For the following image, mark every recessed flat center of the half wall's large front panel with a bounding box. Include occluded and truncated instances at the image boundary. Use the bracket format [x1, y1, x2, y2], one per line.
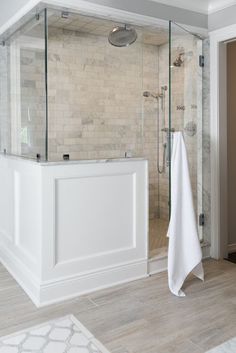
[55, 174, 136, 264]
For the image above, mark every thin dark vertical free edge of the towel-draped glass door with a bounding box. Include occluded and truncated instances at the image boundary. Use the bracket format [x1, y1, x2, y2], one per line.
[168, 21, 172, 218]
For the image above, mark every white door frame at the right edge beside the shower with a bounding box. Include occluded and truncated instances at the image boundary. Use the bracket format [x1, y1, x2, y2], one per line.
[209, 25, 236, 259]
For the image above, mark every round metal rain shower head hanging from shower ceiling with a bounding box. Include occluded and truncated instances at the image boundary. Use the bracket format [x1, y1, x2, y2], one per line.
[108, 25, 138, 47]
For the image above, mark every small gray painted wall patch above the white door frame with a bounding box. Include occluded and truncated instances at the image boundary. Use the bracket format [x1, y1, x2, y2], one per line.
[208, 5, 236, 31]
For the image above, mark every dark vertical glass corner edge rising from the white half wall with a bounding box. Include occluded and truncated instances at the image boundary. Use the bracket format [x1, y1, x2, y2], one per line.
[44, 8, 48, 161]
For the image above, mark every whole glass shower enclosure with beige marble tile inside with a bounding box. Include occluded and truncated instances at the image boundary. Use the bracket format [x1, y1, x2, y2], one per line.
[0, 9, 204, 257]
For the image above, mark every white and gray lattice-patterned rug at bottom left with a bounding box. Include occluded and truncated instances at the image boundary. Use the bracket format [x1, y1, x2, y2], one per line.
[0, 315, 109, 353]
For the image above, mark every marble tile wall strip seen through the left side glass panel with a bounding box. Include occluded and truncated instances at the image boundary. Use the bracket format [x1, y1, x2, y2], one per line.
[20, 48, 46, 159]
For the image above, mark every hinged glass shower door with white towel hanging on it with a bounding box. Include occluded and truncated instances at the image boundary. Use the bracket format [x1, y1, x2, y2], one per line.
[169, 23, 202, 240]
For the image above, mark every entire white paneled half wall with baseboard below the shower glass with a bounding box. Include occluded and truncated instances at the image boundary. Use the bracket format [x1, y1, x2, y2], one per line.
[0, 156, 148, 306]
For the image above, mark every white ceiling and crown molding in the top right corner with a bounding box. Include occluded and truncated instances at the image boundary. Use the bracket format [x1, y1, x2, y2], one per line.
[151, 0, 236, 14]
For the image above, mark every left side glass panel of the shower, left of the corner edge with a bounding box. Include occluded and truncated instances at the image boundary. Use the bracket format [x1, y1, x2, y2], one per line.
[0, 12, 46, 160]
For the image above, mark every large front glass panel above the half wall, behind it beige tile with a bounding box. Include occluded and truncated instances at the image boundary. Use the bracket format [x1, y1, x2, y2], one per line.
[45, 11, 143, 161]
